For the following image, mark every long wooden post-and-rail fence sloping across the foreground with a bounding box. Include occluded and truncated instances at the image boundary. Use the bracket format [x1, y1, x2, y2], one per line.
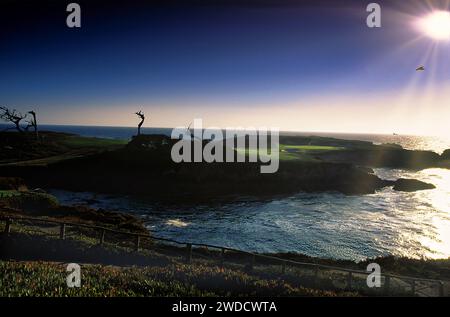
[0, 216, 450, 296]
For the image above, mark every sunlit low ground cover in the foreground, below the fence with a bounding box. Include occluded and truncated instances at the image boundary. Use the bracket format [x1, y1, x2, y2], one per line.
[0, 262, 355, 297]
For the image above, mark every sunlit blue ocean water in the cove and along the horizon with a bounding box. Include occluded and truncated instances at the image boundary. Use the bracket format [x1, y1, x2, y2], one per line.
[2, 126, 450, 261]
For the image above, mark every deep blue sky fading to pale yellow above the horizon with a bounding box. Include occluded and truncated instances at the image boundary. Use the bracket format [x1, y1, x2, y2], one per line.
[0, 0, 450, 135]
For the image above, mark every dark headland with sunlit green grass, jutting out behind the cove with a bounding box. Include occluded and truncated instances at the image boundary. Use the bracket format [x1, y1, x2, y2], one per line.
[0, 133, 446, 199]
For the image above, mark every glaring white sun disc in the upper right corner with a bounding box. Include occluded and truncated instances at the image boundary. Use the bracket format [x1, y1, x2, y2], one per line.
[418, 11, 450, 40]
